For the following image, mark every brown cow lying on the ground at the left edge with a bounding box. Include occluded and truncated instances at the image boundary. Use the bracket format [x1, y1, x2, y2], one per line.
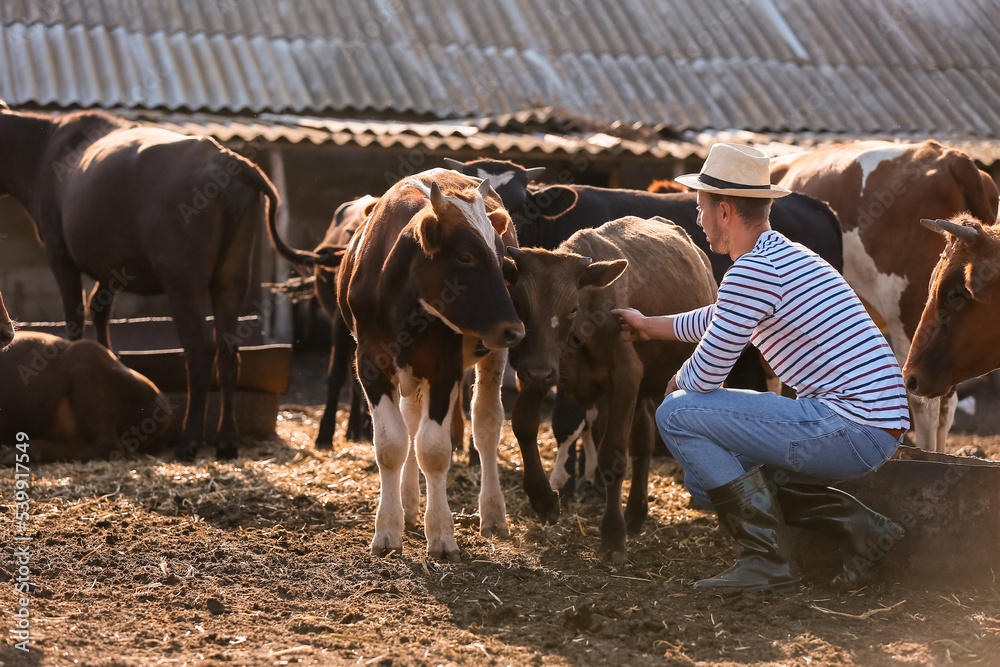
[0, 331, 176, 465]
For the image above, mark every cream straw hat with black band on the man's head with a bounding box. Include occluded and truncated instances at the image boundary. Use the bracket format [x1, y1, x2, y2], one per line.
[675, 144, 791, 198]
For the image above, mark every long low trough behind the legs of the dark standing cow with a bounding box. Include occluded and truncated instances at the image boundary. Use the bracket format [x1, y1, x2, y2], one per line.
[18, 316, 292, 438]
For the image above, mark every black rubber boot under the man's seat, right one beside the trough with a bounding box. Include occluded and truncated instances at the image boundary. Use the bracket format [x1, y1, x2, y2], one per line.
[777, 484, 903, 589]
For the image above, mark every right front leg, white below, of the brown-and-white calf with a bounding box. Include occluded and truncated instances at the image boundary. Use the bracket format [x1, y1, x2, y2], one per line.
[414, 374, 462, 561]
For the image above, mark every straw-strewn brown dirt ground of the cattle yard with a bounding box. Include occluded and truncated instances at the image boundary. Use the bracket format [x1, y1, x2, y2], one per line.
[0, 358, 1000, 667]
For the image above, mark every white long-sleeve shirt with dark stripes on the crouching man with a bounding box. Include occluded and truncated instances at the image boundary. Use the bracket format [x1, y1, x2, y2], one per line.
[674, 231, 909, 429]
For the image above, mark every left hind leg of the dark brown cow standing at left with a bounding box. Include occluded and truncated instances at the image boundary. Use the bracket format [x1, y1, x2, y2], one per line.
[168, 292, 212, 461]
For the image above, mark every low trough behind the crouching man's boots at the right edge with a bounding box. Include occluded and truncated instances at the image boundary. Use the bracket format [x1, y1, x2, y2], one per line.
[793, 446, 1000, 586]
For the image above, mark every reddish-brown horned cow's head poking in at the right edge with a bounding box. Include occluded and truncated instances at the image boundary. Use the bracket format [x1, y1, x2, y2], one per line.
[903, 213, 1000, 398]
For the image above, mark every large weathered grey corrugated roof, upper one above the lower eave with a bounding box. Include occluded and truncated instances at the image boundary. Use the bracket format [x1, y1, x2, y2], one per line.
[0, 0, 1000, 137]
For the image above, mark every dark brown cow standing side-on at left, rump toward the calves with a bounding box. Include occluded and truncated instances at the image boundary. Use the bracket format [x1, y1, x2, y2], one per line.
[0, 110, 321, 460]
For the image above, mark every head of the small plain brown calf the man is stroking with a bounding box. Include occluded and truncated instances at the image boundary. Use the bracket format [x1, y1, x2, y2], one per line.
[507, 248, 628, 386]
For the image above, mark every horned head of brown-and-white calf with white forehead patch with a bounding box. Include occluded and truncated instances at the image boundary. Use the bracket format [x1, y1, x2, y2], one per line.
[409, 181, 524, 349]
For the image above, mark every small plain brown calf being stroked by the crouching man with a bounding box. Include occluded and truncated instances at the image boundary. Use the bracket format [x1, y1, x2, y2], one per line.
[508, 217, 716, 563]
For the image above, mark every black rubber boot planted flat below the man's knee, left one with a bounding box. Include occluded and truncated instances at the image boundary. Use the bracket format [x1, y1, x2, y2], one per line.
[695, 466, 799, 592]
